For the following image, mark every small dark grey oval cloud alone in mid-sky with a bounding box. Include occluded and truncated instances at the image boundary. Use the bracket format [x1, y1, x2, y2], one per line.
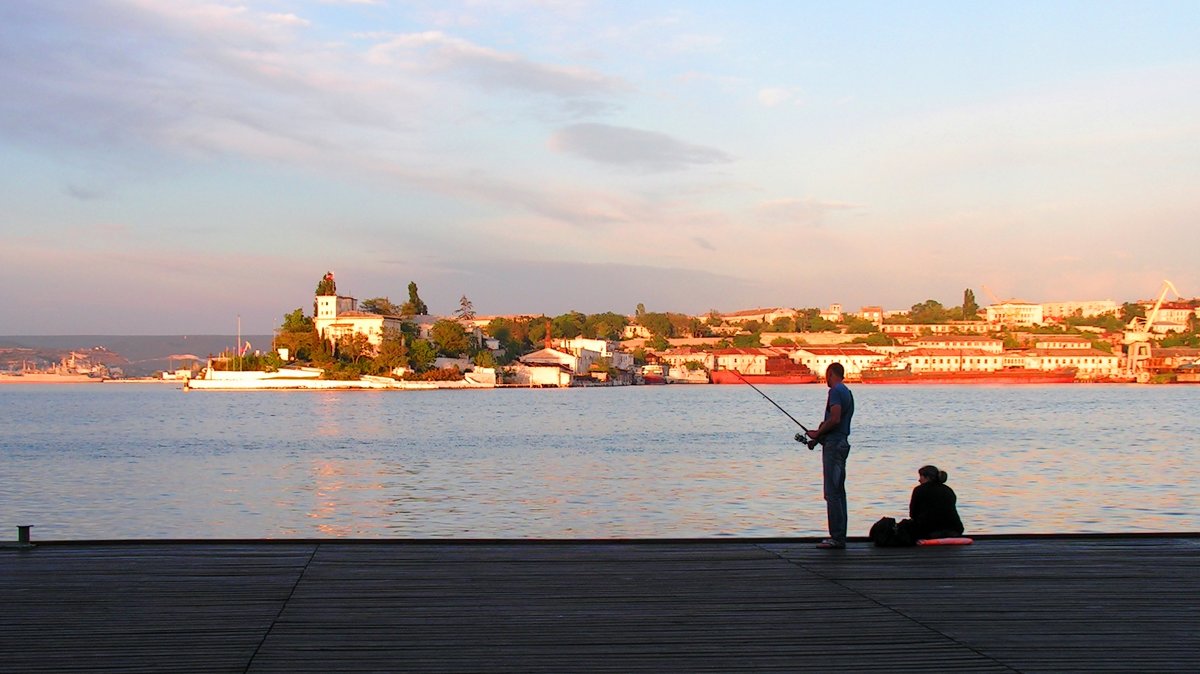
[550, 124, 733, 171]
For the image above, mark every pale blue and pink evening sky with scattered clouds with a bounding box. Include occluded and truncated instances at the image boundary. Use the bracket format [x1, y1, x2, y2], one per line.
[0, 0, 1200, 335]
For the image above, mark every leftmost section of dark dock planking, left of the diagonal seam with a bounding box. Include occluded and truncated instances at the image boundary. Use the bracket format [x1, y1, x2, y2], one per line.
[0, 544, 314, 672]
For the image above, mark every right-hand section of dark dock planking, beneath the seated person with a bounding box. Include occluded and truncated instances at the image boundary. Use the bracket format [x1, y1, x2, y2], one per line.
[774, 537, 1200, 672]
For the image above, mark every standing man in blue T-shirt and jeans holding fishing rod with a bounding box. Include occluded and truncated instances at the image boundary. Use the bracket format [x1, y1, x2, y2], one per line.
[809, 362, 854, 549]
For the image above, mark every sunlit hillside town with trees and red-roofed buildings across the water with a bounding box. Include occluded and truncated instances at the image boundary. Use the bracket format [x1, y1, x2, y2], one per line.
[179, 272, 1200, 387]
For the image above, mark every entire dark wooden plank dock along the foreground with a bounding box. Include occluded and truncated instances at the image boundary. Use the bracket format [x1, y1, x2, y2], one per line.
[0, 535, 1200, 673]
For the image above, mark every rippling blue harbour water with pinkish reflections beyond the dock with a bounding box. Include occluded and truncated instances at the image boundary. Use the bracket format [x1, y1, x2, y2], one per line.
[0, 384, 1200, 540]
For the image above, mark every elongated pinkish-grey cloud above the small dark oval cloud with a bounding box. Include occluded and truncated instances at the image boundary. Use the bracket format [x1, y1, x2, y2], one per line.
[366, 31, 629, 98]
